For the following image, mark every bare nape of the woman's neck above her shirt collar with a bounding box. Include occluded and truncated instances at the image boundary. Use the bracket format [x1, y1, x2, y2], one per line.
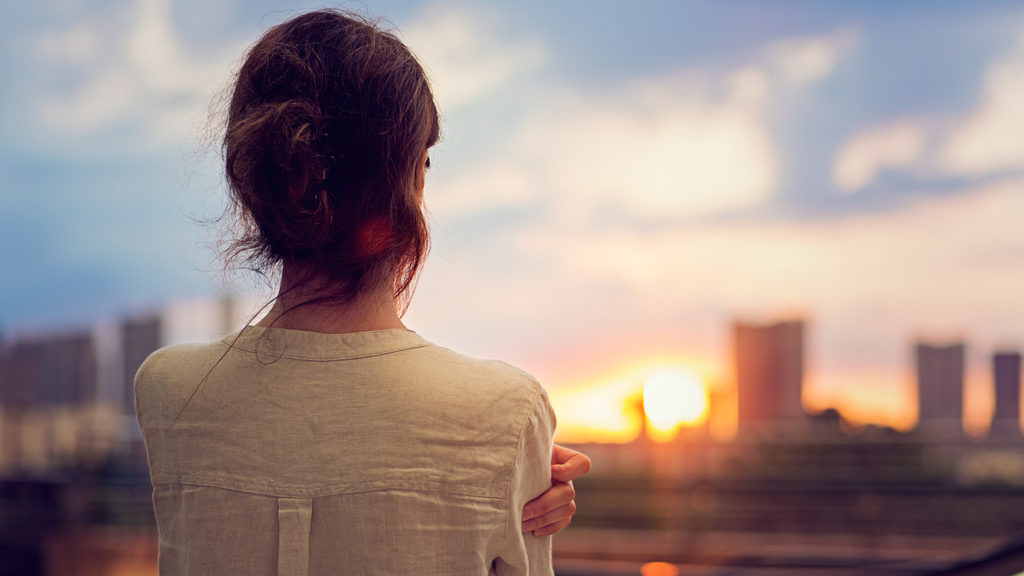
[256, 263, 406, 334]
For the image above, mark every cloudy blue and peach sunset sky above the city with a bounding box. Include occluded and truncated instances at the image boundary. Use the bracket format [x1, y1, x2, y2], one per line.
[0, 0, 1024, 440]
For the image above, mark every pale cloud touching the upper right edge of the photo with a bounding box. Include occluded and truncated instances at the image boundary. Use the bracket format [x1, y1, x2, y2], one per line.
[940, 28, 1024, 176]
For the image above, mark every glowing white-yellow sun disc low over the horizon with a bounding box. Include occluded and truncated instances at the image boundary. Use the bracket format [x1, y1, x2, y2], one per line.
[643, 370, 708, 433]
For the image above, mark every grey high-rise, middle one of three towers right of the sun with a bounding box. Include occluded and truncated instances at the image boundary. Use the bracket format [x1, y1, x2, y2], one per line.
[914, 342, 965, 436]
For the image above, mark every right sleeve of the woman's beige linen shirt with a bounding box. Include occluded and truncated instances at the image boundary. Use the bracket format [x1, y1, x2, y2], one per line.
[495, 381, 555, 576]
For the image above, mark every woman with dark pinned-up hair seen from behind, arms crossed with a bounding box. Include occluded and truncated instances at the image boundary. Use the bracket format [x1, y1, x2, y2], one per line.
[135, 10, 589, 576]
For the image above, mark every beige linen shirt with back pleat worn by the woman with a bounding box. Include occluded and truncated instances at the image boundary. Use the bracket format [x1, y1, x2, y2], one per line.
[135, 327, 554, 576]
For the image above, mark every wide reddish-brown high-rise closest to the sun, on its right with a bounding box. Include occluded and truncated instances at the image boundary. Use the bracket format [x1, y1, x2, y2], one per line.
[733, 321, 804, 435]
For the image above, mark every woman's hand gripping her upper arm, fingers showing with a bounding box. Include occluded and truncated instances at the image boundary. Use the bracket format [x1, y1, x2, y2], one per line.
[522, 444, 590, 536]
